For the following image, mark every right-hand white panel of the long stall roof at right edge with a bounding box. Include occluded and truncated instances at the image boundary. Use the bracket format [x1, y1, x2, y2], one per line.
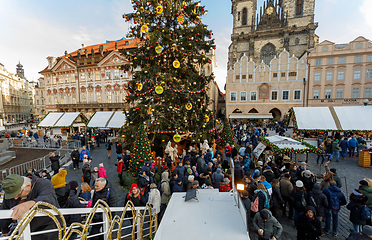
[334, 106, 372, 131]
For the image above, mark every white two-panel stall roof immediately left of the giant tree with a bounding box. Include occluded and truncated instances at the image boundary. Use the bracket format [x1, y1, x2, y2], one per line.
[87, 111, 126, 128]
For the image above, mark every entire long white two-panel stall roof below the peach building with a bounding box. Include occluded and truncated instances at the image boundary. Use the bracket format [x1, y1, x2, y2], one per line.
[292, 106, 372, 131]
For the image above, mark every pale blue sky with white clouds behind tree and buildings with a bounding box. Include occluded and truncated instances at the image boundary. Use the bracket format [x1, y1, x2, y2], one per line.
[0, 0, 372, 92]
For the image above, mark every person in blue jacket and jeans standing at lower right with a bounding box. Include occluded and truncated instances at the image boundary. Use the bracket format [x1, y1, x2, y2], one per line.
[323, 180, 346, 236]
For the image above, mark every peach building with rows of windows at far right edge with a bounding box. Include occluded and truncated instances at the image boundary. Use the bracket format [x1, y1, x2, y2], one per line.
[307, 37, 372, 107]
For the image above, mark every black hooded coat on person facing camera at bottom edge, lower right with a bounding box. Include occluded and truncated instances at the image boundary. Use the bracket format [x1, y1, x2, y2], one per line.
[295, 206, 322, 240]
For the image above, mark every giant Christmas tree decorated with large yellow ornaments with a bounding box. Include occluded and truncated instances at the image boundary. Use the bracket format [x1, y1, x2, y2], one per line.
[121, 0, 215, 148]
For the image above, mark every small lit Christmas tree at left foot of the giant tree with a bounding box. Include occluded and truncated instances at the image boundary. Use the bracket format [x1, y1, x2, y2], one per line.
[129, 125, 151, 177]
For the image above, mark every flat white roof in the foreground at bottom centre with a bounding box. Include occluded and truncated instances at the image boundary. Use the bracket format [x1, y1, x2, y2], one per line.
[155, 189, 249, 240]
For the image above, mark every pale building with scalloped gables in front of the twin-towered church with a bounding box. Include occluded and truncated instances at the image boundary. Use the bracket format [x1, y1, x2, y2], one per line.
[226, 51, 308, 119]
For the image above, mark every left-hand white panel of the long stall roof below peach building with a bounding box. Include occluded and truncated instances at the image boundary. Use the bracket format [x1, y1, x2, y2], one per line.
[293, 107, 337, 130]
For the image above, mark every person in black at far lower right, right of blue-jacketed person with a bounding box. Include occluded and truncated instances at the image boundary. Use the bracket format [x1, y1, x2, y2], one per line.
[346, 189, 368, 232]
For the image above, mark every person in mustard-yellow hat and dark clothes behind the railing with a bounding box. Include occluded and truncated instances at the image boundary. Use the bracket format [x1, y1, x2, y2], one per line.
[51, 170, 70, 208]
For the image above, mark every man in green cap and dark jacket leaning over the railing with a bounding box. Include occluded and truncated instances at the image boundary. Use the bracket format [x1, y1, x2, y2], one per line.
[0, 174, 59, 240]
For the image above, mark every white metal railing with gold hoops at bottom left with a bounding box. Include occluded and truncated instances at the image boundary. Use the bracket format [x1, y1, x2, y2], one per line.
[0, 200, 158, 240]
